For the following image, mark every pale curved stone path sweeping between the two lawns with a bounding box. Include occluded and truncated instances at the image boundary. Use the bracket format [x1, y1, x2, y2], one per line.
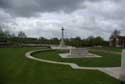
[25, 49, 121, 79]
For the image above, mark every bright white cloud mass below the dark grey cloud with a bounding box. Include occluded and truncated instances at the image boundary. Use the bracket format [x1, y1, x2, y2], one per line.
[0, 0, 125, 39]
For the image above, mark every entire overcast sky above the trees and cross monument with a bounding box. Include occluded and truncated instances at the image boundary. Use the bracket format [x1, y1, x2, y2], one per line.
[0, 0, 125, 39]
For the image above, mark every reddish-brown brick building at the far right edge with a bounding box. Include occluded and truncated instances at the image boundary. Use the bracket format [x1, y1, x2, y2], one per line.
[109, 36, 125, 48]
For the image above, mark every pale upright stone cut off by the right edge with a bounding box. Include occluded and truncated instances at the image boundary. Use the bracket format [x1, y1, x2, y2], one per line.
[120, 50, 125, 81]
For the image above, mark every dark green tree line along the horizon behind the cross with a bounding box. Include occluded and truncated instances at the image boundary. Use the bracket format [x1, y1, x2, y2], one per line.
[0, 28, 108, 47]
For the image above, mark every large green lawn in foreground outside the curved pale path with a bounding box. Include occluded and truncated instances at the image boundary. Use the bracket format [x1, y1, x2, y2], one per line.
[0, 48, 119, 84]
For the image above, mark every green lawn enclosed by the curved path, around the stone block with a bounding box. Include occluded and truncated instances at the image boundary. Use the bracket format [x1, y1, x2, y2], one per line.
[35, 48, 121, 67]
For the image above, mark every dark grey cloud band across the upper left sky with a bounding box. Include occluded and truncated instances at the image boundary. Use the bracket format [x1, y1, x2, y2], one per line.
[0, 0, 83, 16]
